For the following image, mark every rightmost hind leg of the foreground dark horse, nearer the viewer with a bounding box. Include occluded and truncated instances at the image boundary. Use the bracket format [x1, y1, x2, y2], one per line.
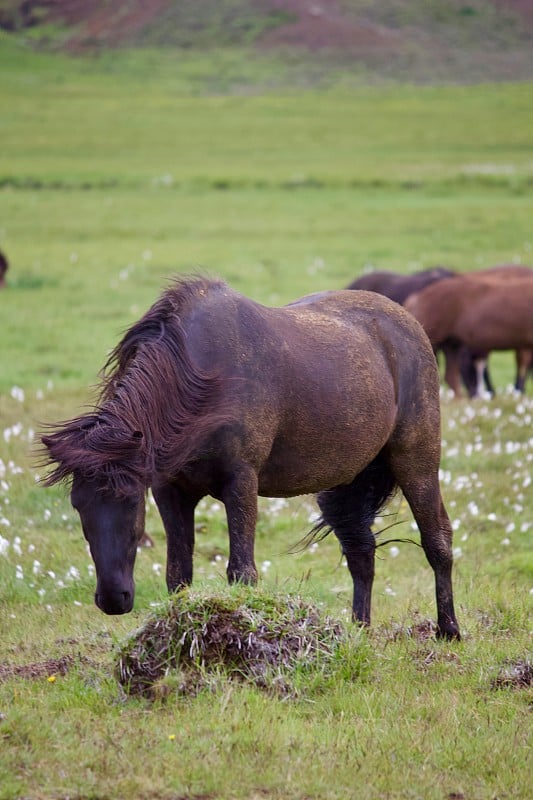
[388, 460, 461, 639]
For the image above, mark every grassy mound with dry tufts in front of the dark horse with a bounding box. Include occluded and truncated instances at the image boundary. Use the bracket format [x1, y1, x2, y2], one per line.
[116, 587, 362, 698]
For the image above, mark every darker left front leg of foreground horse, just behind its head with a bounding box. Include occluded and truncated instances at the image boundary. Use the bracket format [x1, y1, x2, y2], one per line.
[152, 484, 201, 592]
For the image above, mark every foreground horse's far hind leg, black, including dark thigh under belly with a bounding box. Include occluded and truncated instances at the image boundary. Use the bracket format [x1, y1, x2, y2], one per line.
[312, 455, 396, 625]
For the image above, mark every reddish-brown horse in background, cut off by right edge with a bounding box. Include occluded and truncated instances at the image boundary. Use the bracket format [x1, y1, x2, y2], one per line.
[405, 265, 533, 395]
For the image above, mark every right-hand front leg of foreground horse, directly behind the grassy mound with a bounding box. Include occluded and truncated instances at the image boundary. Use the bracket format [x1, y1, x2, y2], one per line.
[221, 467, 257, 584]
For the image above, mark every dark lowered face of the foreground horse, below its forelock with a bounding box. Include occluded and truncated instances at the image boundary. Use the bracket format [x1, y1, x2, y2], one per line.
[70, 473, 144, 614]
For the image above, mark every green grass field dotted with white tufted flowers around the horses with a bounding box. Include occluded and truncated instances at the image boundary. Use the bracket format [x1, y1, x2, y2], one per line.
[0, 29, 533, 800]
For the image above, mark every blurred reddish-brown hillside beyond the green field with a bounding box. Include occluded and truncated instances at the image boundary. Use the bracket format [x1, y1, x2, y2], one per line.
[0, 0, 533, 83]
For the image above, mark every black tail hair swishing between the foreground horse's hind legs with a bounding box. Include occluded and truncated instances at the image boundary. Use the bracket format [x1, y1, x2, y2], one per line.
[303, 452, 397, 546]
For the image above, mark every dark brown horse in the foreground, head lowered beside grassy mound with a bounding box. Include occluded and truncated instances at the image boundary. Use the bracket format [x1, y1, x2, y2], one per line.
[42, 279, 459, 638]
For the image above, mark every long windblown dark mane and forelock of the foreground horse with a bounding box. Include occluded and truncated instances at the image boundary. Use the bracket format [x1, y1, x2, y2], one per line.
[42, 278, 232, 495]
